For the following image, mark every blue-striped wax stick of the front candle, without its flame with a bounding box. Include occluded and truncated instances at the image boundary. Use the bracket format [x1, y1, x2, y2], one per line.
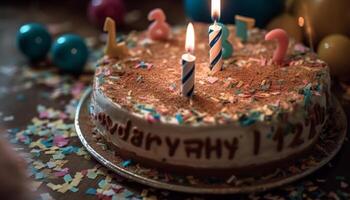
[181, 53, 196, 98]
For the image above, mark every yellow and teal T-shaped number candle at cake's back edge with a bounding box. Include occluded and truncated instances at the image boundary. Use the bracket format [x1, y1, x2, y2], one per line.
[235, 15, 255, 42]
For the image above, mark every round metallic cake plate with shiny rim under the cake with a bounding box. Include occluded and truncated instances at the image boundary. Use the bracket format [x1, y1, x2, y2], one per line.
[75, 89, 347, 194]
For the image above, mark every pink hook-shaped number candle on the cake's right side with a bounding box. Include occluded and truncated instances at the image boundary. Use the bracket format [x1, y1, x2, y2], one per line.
[265, 29, 289, 65]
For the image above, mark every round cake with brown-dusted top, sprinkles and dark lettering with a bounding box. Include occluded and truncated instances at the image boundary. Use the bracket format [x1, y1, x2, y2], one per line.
[90, 24, 331, 176]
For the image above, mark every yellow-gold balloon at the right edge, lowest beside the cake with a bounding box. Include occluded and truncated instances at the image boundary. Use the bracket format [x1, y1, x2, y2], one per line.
[317, 34, 350, 79]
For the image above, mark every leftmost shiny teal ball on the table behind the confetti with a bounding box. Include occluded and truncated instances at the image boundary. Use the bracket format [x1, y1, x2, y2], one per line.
[16, 23, 51, 61]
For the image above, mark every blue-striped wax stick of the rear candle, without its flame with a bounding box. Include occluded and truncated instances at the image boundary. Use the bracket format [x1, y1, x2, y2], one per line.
[209, 23, 223, 74]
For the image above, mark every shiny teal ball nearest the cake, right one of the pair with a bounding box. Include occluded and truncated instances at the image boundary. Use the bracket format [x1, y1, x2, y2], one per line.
[51, 34, 89, 73]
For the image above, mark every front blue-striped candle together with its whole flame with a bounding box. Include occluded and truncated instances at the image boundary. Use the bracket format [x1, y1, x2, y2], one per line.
[181, 23, 196, 98]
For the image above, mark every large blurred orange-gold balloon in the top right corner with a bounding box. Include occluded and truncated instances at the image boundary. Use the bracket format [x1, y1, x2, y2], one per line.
[293, 0, 350, 44]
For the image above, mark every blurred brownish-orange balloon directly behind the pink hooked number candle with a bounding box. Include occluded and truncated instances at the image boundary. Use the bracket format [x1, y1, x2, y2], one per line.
[267, 13, 303, 42]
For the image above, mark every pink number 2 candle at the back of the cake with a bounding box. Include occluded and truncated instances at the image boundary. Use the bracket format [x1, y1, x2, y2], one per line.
[148, 8, 170, 40]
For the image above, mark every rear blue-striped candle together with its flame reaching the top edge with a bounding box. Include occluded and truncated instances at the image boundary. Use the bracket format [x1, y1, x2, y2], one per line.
[209, 0, 223, 74]
